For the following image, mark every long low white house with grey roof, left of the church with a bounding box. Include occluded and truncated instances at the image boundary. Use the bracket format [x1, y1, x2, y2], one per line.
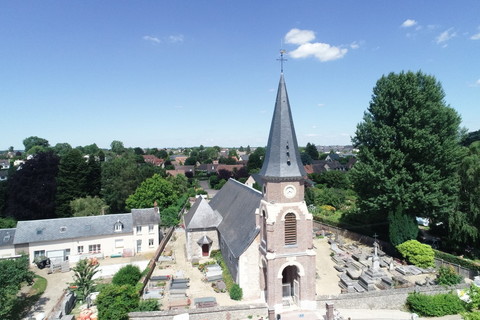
[0, 208, 160, 262]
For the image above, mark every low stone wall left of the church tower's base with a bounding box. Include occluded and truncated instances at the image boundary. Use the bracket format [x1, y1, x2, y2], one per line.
[128, 303, 268, 320]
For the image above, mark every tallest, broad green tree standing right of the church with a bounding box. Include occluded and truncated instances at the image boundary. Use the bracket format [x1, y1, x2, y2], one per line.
[350, 72, 460, 239]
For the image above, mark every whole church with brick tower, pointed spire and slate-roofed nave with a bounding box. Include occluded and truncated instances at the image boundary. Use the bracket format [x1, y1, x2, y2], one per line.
[185, 72, 316, 319]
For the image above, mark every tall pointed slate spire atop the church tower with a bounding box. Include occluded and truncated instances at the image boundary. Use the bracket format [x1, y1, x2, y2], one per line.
[260, 73, 307, 180]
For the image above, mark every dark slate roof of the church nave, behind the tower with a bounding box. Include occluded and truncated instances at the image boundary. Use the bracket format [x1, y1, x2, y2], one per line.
[209, 179, 262, 258]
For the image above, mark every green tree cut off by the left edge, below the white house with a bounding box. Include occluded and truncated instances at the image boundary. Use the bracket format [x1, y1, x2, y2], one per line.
[0, 256, 34, 319]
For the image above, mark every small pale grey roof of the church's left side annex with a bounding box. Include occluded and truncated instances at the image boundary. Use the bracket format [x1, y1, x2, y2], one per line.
[185, 197, 222, 230]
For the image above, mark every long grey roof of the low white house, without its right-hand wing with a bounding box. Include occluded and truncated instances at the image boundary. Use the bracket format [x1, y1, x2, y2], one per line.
[13, 213, 133, 244]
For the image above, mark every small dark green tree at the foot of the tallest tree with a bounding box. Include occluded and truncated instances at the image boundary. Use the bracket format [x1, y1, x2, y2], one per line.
[388, 204, 418, 246]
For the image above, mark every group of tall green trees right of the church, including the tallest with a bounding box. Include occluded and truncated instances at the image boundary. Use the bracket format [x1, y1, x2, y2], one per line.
[350, 72, 480, 254]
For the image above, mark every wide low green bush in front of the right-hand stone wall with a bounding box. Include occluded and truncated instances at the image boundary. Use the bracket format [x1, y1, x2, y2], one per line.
[407, 292, 465, 317]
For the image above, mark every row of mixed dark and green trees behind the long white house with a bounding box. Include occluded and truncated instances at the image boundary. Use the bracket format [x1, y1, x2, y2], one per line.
[0, 137, 190, 227]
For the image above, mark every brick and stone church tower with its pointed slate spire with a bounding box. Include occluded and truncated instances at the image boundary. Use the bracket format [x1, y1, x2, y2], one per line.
[258, 72, 316, 319]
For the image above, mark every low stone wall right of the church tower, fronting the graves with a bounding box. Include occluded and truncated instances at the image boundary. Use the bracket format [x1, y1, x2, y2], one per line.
[317, 284, 468, 310]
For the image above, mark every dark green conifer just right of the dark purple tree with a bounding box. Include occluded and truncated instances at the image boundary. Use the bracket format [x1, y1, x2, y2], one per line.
[55, 149, 88, 217]
